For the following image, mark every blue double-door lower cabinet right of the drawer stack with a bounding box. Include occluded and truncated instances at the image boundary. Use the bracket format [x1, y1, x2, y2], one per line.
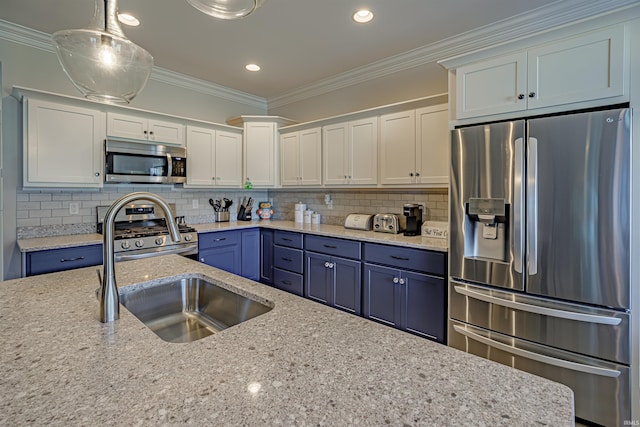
[304, 252, 362, 315]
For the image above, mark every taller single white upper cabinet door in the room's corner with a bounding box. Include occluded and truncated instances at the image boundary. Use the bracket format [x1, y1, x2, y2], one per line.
[244, 122, 277, 187]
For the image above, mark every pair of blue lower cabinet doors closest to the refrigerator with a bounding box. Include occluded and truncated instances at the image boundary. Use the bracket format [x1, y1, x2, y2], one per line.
[363, 263, 446, 343]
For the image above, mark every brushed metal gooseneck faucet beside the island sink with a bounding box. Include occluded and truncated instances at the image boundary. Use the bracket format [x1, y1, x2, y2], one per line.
[98, 191, 180, 323]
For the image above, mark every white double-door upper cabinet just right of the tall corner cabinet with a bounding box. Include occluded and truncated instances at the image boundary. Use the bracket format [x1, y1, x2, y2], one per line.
[280, 127, 322, 186]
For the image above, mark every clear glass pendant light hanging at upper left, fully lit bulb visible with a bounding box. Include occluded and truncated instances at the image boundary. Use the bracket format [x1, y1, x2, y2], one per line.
[53, 0, 153, 104]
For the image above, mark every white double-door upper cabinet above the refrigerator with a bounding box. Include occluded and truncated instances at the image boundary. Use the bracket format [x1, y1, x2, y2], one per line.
[455, 25, 627, 119]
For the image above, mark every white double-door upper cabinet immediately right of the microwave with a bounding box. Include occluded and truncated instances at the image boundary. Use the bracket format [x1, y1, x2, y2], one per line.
[187, 126, 242, 188]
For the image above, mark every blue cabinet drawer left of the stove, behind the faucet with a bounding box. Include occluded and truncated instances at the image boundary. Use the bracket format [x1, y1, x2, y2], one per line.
[26, 245, 102, 276]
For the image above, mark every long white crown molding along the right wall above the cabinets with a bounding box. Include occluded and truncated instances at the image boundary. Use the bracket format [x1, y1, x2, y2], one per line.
[267, 0, 638, 109]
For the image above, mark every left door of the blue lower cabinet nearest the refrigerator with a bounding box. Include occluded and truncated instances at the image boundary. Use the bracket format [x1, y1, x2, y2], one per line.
[362, 264, 401, 327]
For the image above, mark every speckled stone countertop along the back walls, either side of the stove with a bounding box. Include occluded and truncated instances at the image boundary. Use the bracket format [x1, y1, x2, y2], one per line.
[18, 221, 448, 253]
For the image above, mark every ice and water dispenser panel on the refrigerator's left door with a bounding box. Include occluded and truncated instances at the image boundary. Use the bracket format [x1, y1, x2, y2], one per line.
[464, 198, 509, 262]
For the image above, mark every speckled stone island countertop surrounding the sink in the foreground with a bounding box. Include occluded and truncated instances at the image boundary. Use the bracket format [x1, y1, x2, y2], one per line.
[0, 255, 574, 426]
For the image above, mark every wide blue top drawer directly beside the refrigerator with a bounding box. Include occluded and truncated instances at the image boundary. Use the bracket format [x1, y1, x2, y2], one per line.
[364, 243, 445, 276]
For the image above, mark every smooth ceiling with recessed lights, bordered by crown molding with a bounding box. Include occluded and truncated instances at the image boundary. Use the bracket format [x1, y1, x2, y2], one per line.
[0, 0, 624, 99]
